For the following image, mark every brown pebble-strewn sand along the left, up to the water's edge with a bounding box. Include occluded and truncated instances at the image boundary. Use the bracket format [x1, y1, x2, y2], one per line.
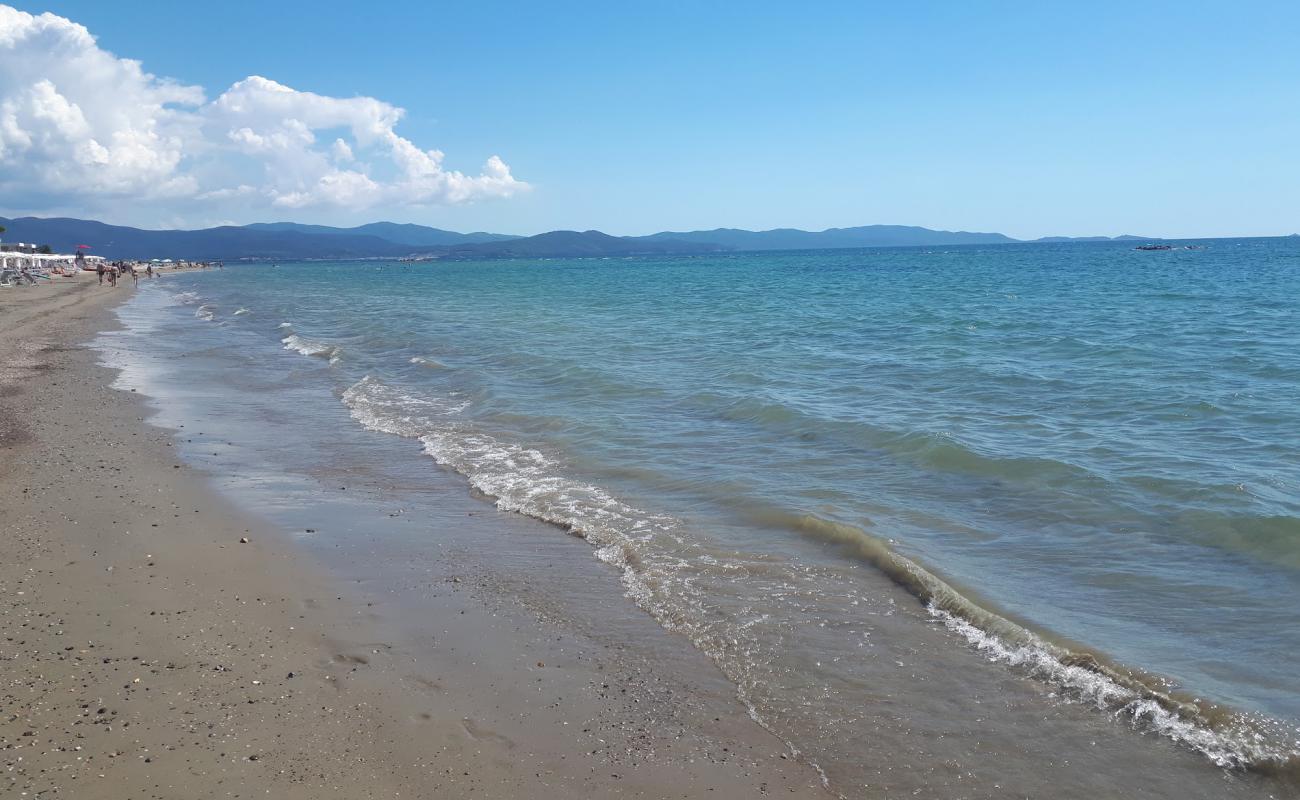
[0, 273, 824, 799]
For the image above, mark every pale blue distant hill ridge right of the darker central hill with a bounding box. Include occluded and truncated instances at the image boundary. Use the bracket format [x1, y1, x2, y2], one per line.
[637, 225, 1017, 250]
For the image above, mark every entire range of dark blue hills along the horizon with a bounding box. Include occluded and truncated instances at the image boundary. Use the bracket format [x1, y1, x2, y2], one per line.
[0, 217, 1149, 260]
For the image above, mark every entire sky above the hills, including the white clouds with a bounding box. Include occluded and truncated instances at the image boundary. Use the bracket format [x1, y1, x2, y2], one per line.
[0, 0, 1300, 238]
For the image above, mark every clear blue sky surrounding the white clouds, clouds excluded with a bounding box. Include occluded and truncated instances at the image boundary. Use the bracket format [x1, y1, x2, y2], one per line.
[0, 0, 1300, 237]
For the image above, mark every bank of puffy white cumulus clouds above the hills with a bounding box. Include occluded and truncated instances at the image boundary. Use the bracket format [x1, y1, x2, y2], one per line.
[0, 5, 528, 215]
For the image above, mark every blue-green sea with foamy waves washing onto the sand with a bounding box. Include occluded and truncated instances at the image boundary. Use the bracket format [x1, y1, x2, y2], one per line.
[98, 238, 1300, 797]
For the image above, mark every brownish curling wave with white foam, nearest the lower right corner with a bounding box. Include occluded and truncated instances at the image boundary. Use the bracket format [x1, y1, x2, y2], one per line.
[777, 514, 1300, 773]
